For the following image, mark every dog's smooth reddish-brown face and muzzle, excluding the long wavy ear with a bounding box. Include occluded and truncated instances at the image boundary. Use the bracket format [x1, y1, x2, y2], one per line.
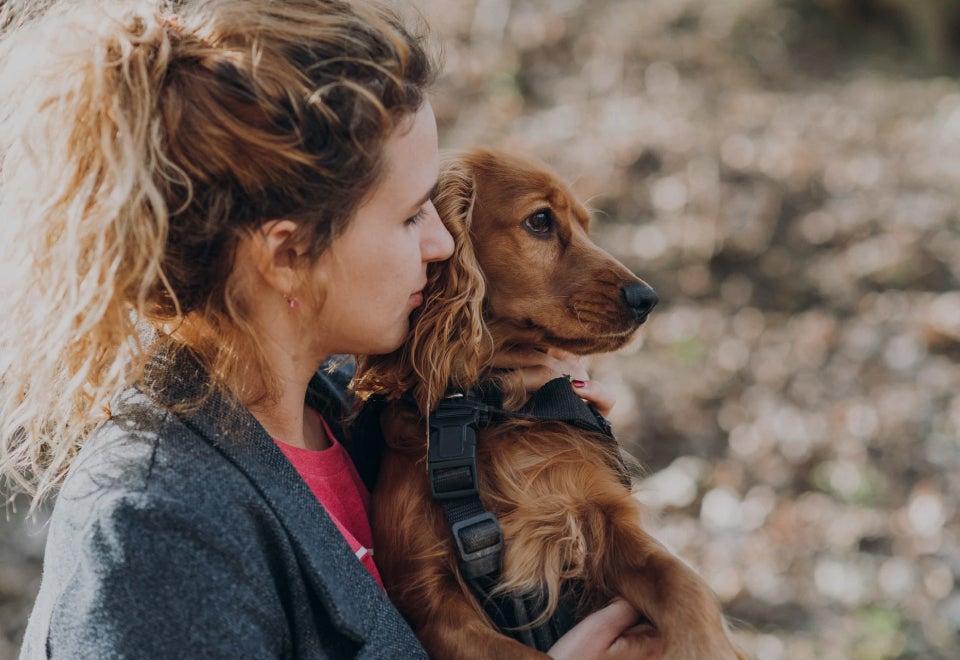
[437, 150, 657, 355]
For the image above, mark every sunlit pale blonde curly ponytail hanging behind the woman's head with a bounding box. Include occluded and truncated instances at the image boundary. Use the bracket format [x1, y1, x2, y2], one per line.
[0, 1, 186, 506]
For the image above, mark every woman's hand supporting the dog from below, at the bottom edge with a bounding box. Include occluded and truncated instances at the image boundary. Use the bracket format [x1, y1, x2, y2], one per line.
[547, 598, 663, 660]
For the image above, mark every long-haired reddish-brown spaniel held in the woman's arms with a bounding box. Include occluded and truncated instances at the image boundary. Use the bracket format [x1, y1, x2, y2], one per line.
[354, 149, 746, 659]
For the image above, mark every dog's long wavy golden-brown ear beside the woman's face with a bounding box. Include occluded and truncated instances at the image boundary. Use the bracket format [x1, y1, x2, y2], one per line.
[353, 157, 493, 415]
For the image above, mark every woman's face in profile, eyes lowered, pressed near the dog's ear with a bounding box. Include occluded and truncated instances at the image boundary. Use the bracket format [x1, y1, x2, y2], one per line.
[312, 103, 453, 356]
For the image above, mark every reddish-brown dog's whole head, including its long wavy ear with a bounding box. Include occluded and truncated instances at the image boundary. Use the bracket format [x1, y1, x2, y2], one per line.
[359, 149, 657, 411]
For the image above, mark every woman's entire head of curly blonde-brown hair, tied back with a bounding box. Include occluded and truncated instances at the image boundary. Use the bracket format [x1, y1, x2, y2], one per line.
[0, 0, 434, 504]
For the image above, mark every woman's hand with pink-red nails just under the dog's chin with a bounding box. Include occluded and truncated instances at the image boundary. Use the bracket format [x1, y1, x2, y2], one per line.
[496, 348, 617, 417]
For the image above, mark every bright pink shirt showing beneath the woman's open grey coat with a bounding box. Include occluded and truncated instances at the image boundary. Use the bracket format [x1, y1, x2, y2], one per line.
[273, 415, 383, 586]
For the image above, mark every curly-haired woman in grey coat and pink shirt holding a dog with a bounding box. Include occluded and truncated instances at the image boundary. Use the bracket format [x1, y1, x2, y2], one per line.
[0, 0, 655, 658]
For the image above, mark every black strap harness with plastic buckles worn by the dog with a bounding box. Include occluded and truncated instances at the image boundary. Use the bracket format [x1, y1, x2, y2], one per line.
[427, 378, 630, 651]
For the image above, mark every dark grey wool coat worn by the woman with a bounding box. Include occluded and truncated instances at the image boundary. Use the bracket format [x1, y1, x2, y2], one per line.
[21, 348, 426, 660]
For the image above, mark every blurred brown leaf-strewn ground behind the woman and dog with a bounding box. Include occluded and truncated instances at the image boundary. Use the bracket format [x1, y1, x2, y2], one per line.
[0, 0, 960, 660]
